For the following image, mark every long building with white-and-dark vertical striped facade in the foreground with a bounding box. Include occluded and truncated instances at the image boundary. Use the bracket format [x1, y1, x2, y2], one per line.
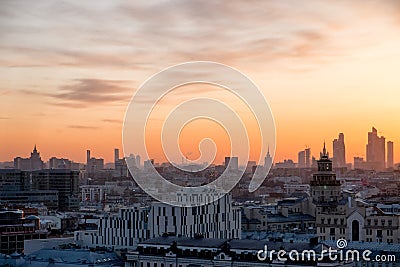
[74, 195, 241, 249]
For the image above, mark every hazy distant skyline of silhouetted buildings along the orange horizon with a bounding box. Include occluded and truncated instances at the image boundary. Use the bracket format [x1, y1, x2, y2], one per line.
[0, 127, 400, 170]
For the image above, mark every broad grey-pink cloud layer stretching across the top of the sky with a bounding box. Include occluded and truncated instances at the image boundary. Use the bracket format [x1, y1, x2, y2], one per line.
[0, 0, 400, 72]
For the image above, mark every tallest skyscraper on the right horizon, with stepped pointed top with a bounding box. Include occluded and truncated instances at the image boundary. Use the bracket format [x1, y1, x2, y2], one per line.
[366, 127, 386, 170]
